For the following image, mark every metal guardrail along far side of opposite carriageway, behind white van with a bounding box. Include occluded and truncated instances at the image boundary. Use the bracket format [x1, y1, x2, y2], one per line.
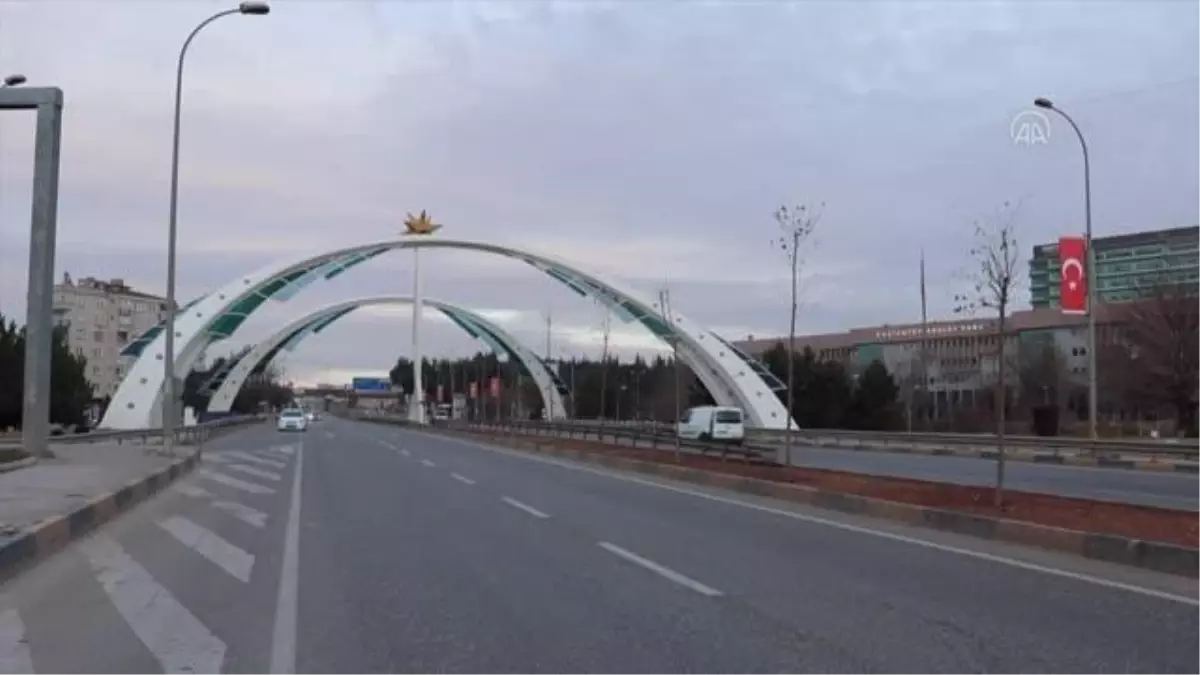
[554, 419, 1200, 460]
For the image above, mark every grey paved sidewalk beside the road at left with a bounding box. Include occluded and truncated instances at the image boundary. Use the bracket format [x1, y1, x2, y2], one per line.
[0, 443, 192, 535]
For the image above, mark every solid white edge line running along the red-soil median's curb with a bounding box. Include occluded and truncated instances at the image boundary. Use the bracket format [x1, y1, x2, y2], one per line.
[431, 435, 1200, 607]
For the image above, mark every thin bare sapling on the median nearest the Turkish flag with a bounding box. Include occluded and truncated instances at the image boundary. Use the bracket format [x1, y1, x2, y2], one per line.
[954, 202, 1021, 507]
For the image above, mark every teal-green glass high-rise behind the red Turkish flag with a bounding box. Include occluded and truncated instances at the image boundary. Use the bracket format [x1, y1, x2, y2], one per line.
[1030, 226, 1200, 309]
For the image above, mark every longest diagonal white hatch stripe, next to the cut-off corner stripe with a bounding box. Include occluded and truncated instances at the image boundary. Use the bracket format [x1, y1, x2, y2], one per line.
[80, 534, 226, 675]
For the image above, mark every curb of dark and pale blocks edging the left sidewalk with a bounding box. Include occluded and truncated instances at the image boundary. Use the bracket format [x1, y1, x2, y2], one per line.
[0, 452, 200, 584]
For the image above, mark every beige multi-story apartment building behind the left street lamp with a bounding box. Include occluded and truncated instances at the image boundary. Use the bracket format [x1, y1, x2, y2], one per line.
[54, 274, 166, 399]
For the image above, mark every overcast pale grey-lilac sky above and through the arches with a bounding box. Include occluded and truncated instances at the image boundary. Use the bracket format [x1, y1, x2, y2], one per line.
[0, 0, 1200, 382]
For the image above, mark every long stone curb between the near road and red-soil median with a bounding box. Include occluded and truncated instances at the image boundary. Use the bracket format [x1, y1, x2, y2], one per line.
[405, 429, 1200, 578]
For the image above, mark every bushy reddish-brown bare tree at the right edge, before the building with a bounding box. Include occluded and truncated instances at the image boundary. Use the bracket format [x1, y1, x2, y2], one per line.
[1124, 280, 1200, 432]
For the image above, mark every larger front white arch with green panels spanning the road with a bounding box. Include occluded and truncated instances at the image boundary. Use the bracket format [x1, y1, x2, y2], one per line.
[101, 235, 788, 429]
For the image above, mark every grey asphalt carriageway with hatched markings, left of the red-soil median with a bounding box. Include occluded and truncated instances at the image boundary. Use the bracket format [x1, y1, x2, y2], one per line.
[0, 419, 1200, 675]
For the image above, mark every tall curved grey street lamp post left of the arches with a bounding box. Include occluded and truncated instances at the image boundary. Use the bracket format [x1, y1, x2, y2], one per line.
[162, 0, 271, 453]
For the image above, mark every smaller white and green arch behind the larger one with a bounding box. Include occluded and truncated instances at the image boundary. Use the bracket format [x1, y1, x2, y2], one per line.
[208, 295, 566, 419]
